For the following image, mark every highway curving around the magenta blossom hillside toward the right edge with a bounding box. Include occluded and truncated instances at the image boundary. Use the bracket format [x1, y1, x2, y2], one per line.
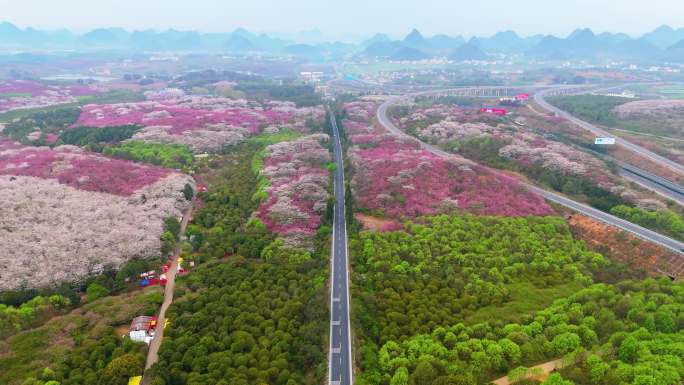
[377, 97, 684, 254]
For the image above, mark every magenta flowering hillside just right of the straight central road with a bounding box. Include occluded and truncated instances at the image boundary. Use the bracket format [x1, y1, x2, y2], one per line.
[343, 102, 553, 218]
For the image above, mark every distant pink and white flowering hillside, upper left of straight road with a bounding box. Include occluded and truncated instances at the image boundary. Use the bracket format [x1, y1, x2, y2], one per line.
[74, 94, 325, 152]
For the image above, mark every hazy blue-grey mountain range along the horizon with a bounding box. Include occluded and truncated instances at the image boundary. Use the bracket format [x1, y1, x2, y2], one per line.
[0, 22, 684, 63]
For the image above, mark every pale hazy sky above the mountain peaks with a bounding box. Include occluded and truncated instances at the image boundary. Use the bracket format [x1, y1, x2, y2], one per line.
[0, 0, 684, 37]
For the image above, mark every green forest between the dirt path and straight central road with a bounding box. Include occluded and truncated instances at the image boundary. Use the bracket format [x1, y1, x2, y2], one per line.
[154, 134, 328, 385]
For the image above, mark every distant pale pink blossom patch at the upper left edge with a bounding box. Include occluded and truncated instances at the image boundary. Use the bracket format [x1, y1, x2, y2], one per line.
[0, 80, 101, 112]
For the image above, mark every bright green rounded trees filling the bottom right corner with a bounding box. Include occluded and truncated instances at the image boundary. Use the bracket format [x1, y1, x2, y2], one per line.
[366, 279, 684, 385]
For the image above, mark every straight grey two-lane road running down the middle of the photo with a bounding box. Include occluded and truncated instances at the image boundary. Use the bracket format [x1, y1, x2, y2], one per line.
[328, 111, 353, 385]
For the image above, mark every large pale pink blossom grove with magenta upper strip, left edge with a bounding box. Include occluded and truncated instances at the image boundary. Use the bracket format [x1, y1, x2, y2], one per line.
[0, 140, 194, 290]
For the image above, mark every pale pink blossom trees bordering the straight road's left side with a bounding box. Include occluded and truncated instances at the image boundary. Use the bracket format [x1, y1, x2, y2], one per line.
[256, 134, 330, 248]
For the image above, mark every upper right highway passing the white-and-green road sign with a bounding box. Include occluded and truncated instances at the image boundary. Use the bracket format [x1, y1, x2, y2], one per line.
[534, 88, 684, 175]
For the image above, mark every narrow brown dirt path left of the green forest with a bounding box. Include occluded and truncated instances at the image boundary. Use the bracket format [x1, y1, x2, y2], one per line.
[141, 199, 195, 385]
